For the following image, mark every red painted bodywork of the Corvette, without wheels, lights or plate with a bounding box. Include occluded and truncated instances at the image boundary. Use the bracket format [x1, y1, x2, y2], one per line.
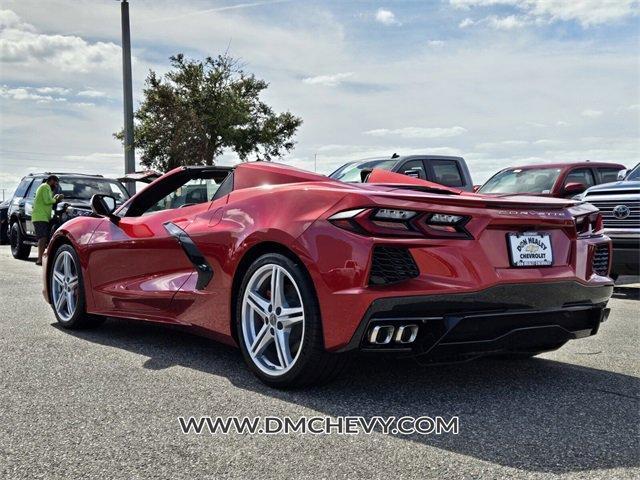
[43, 163, 612, 350]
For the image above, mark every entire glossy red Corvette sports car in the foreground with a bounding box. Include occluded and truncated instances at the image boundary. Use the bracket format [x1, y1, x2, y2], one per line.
[43, 162, 613, 387]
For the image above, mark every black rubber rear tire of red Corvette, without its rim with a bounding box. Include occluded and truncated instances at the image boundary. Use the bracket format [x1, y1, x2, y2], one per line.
[235, 253, 346, 389]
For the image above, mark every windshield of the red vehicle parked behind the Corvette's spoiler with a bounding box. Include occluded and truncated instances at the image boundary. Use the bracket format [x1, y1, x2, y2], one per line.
[478, 168, 560, 193]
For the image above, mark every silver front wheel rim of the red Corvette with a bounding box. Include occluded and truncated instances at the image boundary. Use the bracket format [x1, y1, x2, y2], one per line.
[51, 251, 78, 322]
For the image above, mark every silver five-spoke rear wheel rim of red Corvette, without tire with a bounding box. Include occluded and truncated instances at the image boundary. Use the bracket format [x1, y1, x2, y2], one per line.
[241, 264, 305, 376]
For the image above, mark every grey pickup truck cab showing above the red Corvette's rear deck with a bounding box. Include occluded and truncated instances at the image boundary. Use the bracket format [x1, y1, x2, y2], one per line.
[329, 154, 473, 192]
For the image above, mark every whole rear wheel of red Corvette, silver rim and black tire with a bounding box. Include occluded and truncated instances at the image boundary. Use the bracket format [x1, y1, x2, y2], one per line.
[236, 253, 344, 388]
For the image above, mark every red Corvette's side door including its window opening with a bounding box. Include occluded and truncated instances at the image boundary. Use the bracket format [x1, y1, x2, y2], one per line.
[88, 169, 230, 322]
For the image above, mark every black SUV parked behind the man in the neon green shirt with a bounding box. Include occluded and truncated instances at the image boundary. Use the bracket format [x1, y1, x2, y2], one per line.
[7, 172, 129, 260]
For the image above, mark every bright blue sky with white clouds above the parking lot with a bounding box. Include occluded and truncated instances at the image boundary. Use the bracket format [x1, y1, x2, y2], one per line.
[0, 0, 640, 198]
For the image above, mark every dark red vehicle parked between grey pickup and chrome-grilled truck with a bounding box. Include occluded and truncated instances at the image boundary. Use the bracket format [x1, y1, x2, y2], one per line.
[477, 161, 625, 198]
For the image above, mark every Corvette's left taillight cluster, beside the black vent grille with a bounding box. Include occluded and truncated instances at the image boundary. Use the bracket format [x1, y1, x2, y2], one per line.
[329, 208, 472, 239]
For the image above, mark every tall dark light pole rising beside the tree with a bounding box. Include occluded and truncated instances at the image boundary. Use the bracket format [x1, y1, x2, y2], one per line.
[120, 0, 136, 194]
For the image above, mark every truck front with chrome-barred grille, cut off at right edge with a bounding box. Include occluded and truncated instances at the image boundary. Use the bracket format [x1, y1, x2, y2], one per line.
[582, 164, 640, 277]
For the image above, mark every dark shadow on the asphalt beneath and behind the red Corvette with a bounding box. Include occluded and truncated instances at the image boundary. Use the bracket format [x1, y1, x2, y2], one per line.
[57, 320, 640, 474]
